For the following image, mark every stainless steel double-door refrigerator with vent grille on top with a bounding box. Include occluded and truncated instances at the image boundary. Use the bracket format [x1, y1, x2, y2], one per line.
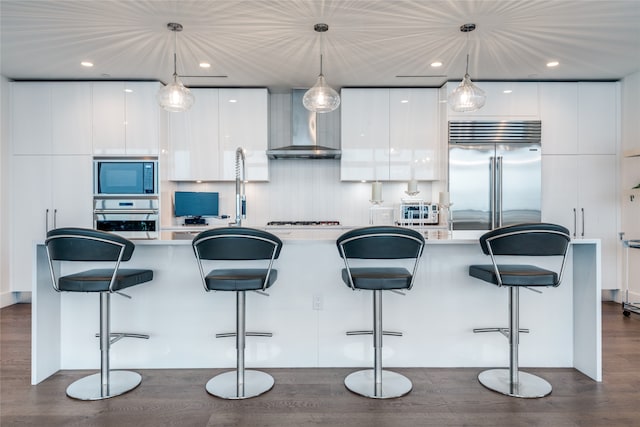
[449, 121, 541, 230]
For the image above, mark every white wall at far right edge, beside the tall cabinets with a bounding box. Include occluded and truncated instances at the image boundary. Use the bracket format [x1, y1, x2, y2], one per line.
[620, 72, 640, 304]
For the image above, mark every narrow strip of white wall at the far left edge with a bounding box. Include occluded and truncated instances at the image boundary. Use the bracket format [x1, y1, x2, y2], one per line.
[0, 76, 13, 307]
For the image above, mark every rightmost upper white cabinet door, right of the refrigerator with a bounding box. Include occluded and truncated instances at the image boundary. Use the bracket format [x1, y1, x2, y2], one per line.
[576, 83, 618, 154]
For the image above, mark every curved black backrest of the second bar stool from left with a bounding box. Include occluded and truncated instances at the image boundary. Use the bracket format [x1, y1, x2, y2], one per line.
[192, 227, 282, 261]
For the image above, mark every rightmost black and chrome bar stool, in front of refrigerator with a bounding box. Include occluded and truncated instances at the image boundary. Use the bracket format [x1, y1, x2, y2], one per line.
[469, 223, 571, 398]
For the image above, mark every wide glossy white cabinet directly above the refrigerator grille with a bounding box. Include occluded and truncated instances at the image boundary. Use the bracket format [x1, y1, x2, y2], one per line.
[447, 82, 539, 120]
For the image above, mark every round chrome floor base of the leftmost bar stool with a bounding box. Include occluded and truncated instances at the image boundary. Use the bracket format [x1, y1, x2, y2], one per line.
[67, 371, 142, 400]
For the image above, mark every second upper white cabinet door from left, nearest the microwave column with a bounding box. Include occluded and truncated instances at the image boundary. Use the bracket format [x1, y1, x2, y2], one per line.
[51, 83, 92, 154]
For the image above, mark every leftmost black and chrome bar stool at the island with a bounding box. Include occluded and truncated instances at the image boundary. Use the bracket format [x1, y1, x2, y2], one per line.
[45, 228, 153, 400]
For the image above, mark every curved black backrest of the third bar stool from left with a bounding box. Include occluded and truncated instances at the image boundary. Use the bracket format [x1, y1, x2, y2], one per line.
[336, 226, 424, 259]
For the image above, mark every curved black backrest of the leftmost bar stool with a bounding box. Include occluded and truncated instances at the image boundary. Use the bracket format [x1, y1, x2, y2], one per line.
[45, 227, 135, 261]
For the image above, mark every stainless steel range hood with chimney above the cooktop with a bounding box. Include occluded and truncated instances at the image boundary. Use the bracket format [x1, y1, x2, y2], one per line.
[267, 89, 342, 159]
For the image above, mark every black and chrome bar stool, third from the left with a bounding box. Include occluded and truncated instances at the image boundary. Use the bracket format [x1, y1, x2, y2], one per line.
[336, 226, 425, 399]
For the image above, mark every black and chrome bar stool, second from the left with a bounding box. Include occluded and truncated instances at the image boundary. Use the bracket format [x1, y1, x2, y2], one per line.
[192, 227, 282, 399]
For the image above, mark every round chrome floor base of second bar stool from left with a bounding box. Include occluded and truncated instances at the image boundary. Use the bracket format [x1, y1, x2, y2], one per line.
[205, 370, 274, 399]
